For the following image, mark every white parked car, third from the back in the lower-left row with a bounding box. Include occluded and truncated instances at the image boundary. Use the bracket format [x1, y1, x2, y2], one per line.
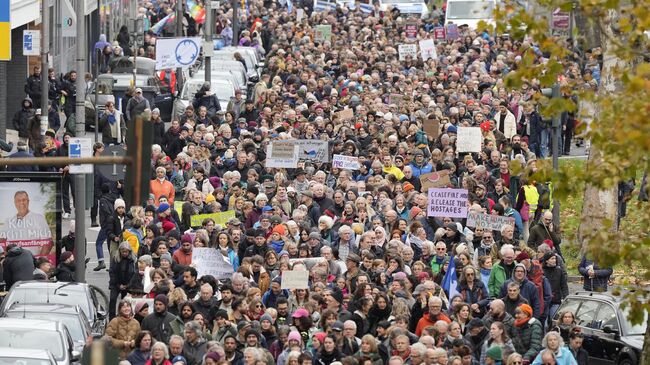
[0, 318, 81, 365]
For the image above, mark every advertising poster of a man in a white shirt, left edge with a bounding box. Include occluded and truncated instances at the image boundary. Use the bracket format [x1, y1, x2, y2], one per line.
[0, 172, 61, 265]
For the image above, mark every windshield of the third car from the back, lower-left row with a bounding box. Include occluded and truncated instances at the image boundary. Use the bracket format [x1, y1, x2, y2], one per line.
[0, 328, 65, 358]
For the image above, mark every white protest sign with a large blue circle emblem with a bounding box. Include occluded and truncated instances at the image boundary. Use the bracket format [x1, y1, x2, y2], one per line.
[156, 37, 203, 70]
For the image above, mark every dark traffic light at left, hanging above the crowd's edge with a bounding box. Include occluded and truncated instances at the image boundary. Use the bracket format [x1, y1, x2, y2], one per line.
[124, 113, 153, 207]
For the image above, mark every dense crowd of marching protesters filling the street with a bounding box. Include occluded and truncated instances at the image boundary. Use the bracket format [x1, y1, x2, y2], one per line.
[5, 1, 612, 365]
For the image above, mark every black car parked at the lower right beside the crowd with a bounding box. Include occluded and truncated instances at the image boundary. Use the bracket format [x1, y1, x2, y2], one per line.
[553, 292, 646, 365]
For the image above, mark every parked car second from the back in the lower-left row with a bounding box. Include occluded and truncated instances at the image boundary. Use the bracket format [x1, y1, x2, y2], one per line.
[4, 303, 93, 352]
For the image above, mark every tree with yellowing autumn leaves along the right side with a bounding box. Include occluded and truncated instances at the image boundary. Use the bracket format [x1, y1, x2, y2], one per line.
[486, 0, 650, 364]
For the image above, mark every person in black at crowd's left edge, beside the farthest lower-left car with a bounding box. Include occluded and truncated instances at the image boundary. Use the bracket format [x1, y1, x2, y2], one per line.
[108, 241, 136, 319]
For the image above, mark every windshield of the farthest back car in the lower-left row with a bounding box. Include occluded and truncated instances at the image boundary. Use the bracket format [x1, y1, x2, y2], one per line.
[5, 285, 93, 318]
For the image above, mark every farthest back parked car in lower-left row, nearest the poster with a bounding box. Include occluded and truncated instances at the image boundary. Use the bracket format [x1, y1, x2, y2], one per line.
[0, 281, 108, 333]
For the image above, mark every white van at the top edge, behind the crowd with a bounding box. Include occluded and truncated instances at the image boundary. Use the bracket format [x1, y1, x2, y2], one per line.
[445, 0, 496, 29]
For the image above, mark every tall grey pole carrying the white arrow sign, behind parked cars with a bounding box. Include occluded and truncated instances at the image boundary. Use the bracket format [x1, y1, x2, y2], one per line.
[74, 0, 86, 283]
